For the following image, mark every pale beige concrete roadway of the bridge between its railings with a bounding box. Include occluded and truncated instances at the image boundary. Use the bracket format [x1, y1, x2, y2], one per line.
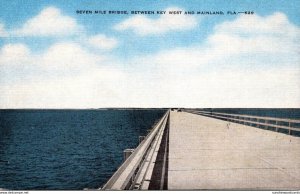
[168, 111, 300, 190]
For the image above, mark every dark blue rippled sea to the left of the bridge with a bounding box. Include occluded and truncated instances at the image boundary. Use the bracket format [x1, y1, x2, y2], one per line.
[0, 110, 164, 190]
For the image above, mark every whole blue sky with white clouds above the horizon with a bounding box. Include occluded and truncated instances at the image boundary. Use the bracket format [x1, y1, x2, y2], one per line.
[0, 0, 300, 109]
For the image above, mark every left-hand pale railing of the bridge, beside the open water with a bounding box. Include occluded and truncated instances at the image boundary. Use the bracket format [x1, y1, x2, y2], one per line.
[100, 110, 170, 190]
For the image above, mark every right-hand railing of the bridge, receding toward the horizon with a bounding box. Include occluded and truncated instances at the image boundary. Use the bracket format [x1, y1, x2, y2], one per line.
[185, 109, 300, 134]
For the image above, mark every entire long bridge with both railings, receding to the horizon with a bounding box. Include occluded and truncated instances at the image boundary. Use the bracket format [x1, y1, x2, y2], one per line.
[101, 109, 300, 190]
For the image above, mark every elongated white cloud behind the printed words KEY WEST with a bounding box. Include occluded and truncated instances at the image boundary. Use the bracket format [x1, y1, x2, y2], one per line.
[115, 7, 197, 36]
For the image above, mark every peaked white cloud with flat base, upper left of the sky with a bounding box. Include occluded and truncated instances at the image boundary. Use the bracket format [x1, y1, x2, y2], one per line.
[11, 7, 82, 36]
